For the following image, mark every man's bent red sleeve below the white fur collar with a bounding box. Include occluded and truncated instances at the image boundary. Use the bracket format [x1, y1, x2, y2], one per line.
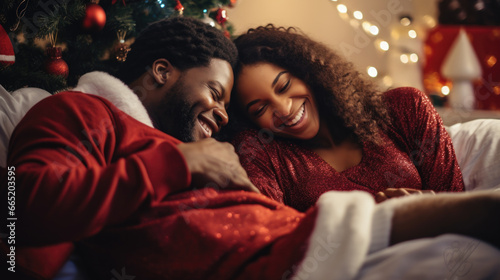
[8, 93, 190, 245]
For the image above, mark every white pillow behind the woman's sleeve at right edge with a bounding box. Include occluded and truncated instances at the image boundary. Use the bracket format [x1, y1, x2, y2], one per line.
[447, 119, 500, 191]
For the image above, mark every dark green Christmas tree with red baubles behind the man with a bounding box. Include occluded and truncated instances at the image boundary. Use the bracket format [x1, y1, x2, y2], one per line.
[0, 0, 236, 93]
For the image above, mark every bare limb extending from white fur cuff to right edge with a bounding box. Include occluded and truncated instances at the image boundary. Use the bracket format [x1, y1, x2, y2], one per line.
[390, 192, 500, 248]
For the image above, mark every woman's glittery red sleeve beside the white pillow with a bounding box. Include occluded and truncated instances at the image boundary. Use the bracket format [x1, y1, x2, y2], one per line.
[385, 88, 464, 192]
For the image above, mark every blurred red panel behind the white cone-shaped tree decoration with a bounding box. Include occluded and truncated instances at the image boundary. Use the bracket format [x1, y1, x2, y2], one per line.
[422, 25, 500, 110]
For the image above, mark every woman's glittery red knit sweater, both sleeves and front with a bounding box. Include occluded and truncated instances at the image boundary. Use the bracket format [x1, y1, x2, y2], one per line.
[233, 88, 464, 211]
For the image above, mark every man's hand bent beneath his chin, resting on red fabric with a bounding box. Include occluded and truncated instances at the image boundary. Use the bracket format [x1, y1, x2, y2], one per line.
[177, 138, 260, 193]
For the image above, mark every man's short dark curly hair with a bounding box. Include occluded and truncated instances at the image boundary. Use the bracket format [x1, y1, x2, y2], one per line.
[118, 17, 238, 84]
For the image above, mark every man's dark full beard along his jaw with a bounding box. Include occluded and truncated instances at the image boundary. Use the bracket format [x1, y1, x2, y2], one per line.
[156, 78, 196, 142]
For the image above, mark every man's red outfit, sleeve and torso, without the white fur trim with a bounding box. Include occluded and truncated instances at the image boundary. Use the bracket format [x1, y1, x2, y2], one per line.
[2, 92, 317, 279]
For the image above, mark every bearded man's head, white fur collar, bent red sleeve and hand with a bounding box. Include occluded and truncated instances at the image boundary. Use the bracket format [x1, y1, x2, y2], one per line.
[2, 18, 254, 279]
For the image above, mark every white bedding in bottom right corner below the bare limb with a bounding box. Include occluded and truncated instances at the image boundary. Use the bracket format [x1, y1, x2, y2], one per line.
[358, 234, 500, 280]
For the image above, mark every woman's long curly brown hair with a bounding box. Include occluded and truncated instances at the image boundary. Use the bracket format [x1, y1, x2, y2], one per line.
[230, 24, 389, 144]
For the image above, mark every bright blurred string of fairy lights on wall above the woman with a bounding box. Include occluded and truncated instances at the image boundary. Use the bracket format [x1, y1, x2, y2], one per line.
[329, 0, 435, 86]
